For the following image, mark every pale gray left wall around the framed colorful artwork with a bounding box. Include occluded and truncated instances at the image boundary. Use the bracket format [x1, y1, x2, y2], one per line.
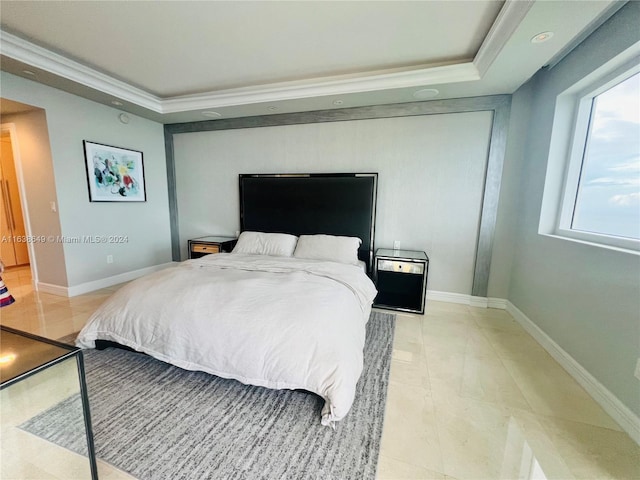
[0, 72, 171, 287]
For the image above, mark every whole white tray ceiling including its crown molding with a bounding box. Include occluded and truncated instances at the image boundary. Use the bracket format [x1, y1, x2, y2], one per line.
[0, 0, 624, 123]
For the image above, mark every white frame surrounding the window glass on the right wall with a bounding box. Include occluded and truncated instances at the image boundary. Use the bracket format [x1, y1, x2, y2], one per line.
[539, 49, 640, 254]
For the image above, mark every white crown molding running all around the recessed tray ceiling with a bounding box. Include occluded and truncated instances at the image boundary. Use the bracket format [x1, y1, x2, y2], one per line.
[0, 0, 534, 114]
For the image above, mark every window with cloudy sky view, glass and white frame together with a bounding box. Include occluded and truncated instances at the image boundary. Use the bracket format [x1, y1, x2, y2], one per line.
[541, 58, 640, 251]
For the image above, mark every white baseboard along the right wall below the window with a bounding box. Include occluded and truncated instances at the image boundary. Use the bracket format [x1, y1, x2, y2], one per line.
[506, 301, 640, 444]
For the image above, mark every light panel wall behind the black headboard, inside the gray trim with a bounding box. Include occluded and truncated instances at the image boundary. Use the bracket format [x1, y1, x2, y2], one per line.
[174, 111, 492, 295]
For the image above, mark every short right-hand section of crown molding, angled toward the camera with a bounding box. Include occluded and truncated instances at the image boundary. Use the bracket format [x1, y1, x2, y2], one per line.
[473, 0, 535, 77]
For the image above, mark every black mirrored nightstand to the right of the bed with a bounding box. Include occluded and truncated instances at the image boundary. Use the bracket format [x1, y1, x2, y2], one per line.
[373, 248, 429, 313]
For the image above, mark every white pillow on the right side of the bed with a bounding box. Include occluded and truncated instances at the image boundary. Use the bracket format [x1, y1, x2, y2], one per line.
[293, 235, 362, 265]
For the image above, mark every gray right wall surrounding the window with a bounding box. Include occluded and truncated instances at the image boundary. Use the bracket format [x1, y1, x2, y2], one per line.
[494, 2, 640, 415]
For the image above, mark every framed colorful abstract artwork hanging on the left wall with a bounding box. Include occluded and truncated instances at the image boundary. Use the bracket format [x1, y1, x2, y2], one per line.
[82, 140, 147, 202]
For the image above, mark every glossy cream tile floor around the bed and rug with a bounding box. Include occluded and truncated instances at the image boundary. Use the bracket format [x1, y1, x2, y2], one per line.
[0, 268, 640, 480]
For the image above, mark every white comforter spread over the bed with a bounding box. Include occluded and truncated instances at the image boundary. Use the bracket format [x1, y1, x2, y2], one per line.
[76, 254, 376, 425]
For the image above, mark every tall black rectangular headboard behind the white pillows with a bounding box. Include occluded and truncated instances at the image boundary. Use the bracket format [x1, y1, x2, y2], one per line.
[240, 173, 378, 272]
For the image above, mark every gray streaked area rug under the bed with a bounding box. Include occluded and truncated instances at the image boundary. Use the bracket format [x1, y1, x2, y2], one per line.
[20, 312, 395, 480]
